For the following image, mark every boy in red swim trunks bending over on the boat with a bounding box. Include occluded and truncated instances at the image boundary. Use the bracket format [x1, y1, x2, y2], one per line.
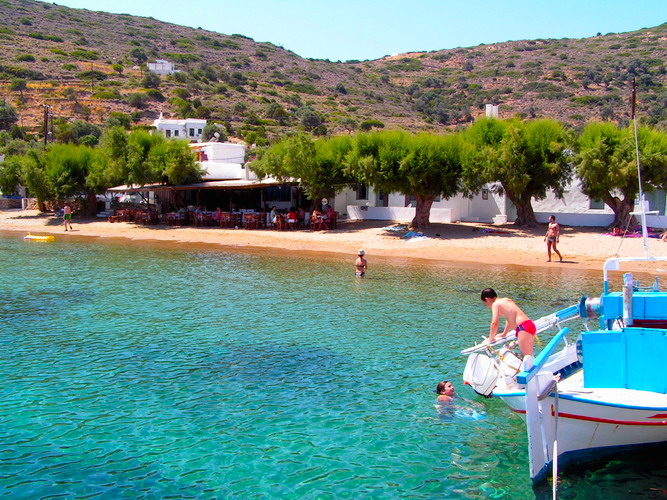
[481, 288, 537, 357]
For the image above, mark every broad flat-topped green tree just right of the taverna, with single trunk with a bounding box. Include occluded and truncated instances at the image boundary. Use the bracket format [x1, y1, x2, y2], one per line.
[347, 131, 463, 228]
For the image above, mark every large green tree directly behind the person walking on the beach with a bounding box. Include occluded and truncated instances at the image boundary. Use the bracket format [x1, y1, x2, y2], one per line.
[464, 118, 572, 226]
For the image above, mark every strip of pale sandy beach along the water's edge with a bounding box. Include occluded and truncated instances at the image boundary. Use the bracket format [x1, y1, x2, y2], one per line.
[5, 210, 667, 270]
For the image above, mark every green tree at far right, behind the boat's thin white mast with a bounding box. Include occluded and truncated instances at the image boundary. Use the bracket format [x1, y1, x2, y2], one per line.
[576, 122, 667, 228]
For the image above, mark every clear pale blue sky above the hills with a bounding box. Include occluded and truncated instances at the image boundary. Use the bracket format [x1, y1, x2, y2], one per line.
[35, 0, 667, 61]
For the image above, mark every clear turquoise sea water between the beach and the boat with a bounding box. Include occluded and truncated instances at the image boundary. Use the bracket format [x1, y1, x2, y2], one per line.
[0, 235, 667, 498]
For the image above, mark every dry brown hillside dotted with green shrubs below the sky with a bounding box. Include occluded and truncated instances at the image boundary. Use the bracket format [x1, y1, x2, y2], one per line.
[0, 0, 667, 142]
